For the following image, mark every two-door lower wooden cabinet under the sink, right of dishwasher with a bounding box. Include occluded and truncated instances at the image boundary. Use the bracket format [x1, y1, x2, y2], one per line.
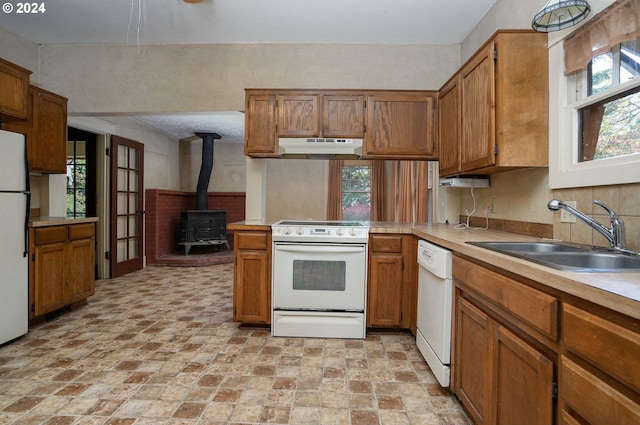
[452, 257, 558, 425]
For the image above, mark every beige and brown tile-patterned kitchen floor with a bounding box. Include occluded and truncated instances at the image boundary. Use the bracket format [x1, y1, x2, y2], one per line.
[0, 264, 471, 425]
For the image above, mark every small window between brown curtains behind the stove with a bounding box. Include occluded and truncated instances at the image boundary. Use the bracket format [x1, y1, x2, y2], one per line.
[342, 165, 371, 221]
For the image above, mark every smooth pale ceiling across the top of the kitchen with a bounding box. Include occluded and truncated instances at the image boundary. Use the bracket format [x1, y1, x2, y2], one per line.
[0, 0, 496, 44]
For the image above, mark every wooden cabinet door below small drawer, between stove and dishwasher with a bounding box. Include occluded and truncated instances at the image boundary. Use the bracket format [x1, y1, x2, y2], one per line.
[367, 253, 403, 328]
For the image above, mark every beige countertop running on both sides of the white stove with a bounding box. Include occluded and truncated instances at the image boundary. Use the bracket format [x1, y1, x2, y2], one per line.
[228, 220, 640, 319]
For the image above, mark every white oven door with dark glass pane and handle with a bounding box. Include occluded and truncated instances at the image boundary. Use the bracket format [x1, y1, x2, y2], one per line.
[272, 242, 367, 312]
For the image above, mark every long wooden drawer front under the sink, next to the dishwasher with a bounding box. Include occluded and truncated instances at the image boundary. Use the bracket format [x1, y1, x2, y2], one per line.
[453, 257, 558, 340]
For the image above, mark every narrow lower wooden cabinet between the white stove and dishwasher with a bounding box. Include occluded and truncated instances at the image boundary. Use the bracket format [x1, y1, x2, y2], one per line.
[367, 234, 417, 332]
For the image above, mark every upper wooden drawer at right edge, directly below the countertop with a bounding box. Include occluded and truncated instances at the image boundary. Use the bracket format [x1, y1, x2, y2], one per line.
[562, 304, 640, 392]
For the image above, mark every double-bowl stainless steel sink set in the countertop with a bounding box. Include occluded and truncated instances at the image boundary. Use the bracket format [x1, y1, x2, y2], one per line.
[467, 238, 640, 273]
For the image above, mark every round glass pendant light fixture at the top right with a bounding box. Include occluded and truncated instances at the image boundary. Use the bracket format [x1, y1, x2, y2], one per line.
[531, 0, 591, 32]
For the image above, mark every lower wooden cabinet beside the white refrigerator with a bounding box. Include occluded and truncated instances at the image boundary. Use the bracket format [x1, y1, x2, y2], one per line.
[29, 223, 95, 319]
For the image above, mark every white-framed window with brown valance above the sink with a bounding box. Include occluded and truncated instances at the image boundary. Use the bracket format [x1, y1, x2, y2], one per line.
[549, 0, 640, 189]
